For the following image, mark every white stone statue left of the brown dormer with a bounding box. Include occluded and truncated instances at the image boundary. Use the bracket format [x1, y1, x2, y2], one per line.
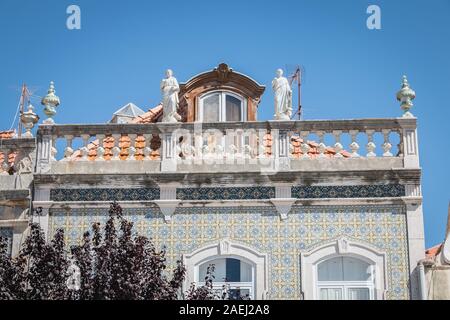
[161, 69, 181, 122]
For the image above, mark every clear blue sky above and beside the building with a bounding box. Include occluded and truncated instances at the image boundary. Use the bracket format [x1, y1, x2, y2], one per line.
[0, 0, 450, 246]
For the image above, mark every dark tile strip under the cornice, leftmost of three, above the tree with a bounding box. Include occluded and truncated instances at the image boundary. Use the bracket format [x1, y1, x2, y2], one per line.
[50, 188, 159, 201]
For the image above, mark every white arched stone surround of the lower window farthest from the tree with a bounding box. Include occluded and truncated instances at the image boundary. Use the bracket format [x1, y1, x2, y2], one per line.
[300, 237, 388, 300]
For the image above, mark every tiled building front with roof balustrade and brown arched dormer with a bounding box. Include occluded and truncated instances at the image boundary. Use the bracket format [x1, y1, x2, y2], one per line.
[0, 64, 425, 300]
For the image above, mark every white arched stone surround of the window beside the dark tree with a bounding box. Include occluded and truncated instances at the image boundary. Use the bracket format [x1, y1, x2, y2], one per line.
[183, 239, 269, 300]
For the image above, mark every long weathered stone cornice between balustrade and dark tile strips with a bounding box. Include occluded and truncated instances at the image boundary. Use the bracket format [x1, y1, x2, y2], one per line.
[34, 169, 421, 187]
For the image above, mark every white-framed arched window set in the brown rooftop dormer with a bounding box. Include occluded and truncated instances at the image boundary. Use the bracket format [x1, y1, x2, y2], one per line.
[197, 91, 247, 122]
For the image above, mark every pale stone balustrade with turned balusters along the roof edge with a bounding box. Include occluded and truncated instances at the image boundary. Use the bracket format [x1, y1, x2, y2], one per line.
[37, 118, 419, 173]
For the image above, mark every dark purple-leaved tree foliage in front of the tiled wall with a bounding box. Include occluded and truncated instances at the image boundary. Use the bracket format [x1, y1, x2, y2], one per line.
[0, 202, 248, 300]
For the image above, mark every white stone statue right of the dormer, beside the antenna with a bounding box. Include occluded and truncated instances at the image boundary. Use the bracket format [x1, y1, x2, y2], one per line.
[272, 69, 292, 120]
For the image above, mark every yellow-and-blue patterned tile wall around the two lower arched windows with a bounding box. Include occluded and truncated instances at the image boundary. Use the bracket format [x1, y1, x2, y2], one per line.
[49, 205, 409, 299]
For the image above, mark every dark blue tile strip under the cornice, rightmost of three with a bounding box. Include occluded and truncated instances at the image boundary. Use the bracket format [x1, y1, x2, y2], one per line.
[292, 184, 405, 199]
